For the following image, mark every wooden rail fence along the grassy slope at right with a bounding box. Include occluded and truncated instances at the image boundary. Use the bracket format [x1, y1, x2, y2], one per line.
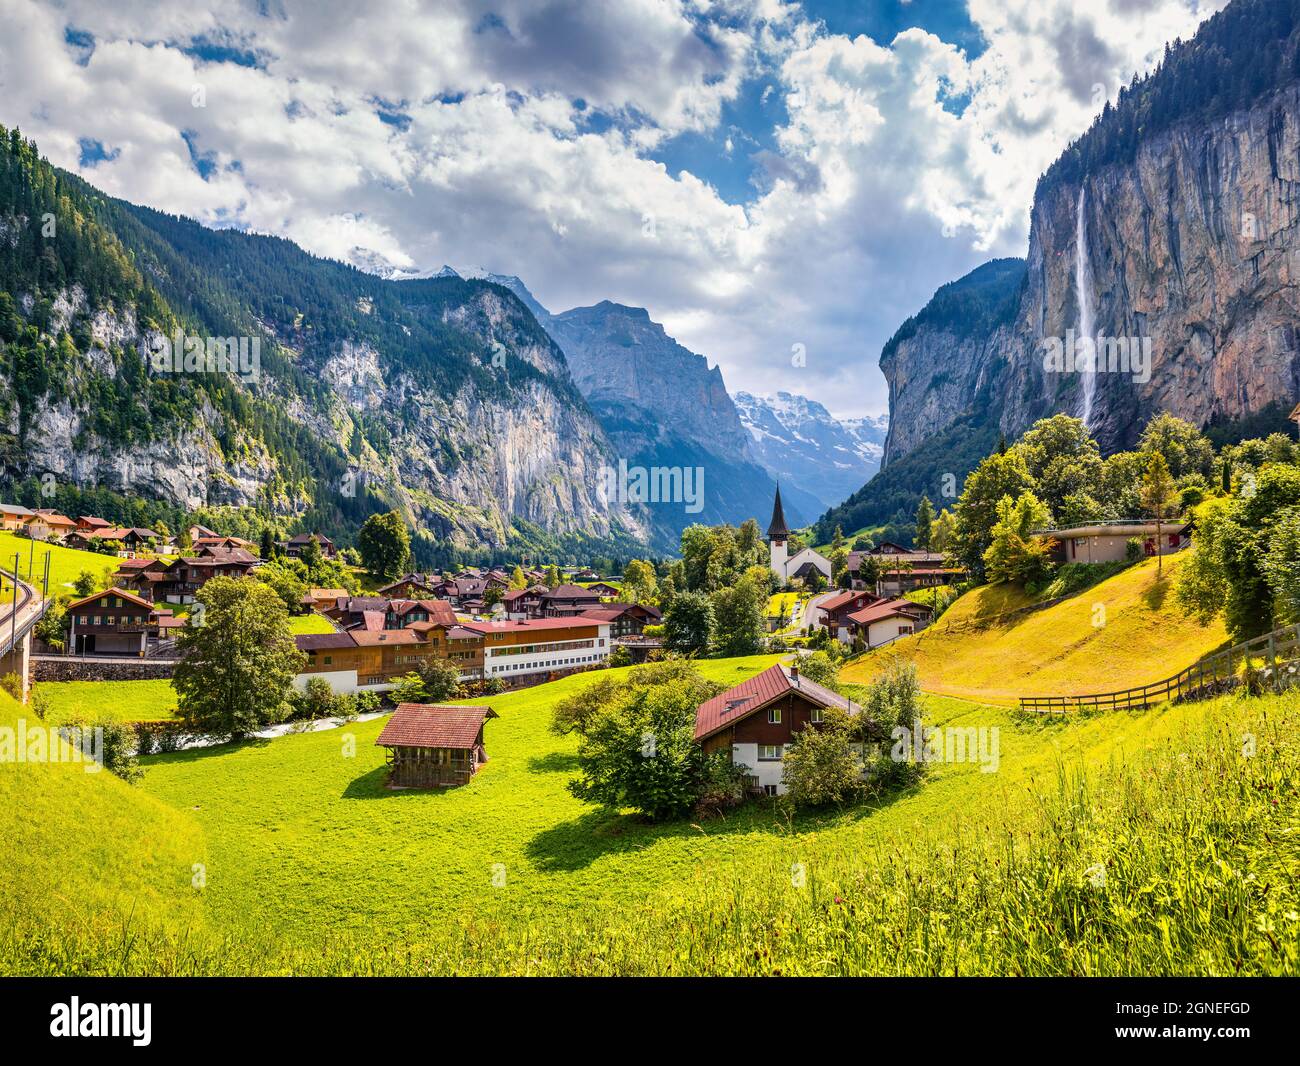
[1021, 625, 1300, 714]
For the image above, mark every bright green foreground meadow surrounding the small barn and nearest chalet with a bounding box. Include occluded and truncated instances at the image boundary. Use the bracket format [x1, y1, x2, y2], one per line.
[0, 644, 1300, 974]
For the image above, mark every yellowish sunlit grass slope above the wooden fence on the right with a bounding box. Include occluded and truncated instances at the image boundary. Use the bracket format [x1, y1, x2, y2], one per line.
[845, 555, 1227, 703]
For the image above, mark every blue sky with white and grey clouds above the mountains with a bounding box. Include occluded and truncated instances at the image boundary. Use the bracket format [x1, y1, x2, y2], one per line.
[0, 0, 1221, 415]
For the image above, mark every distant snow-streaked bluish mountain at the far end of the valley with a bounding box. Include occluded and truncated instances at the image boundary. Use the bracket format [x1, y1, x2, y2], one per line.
[736, 393, 888, 510]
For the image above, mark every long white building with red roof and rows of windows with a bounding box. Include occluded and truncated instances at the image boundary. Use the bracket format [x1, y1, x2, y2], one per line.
[464, 618, 612, 685]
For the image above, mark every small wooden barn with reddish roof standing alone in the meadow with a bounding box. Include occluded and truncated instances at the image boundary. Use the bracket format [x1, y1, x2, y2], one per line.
[374, 703, 497, 788]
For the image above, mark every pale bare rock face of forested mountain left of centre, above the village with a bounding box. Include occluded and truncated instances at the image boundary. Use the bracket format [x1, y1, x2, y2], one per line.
[295, 286, 649, 547]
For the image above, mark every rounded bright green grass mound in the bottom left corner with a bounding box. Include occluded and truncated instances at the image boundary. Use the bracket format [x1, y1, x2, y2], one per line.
[0, 692, 207, 972]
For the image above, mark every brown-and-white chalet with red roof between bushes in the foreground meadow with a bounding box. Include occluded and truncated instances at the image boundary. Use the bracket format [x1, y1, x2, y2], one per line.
[696, 663, 861, 796]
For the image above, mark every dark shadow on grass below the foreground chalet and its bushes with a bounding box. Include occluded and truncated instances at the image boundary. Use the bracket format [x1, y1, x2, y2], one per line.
[524, 784, 924, 871]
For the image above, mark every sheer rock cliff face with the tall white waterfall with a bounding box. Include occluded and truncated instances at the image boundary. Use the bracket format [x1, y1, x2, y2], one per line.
[880, 85, 1300, 465]
